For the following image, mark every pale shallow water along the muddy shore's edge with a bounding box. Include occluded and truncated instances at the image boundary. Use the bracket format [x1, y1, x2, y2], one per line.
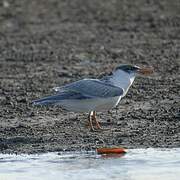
[0, 148, 180, 180]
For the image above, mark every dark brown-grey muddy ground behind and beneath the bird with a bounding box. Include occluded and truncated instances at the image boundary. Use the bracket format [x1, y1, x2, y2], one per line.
[0, 0, 180, 153]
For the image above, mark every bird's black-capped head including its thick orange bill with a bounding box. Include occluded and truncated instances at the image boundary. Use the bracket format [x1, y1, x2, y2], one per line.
[115, 64, 153, 76]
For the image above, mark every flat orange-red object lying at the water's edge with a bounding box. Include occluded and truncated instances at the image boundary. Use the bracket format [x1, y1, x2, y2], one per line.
[97, 148, 127, 154]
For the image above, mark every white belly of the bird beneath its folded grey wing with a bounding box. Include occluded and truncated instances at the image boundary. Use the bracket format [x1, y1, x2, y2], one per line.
[58, 96, 121, 112]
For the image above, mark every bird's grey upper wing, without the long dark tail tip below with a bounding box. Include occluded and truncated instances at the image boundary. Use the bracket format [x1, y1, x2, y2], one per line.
[52, 79, 123, 97]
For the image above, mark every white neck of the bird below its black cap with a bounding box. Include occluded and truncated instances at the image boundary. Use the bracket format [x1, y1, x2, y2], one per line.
[110, 70, 135, 96]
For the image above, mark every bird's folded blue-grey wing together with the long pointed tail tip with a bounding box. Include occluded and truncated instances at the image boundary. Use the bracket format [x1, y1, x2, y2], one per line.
[33, 79, 123, 105]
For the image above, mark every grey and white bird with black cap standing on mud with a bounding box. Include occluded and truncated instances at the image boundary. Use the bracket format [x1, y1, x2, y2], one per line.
[32, 64, 153, 131]
